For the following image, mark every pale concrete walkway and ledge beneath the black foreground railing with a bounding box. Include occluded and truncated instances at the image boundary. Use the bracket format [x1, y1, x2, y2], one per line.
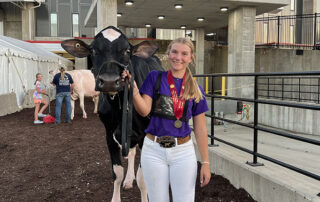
[191, 121, 320, 202]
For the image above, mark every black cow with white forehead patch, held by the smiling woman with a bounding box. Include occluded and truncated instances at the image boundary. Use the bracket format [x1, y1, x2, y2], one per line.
[61, 26, 163, 202]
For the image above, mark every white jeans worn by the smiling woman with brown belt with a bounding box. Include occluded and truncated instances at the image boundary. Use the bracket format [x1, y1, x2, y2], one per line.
[141, 137, 197, 202]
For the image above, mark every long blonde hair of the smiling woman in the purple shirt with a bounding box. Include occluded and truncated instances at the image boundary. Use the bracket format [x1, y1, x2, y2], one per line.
[167, 38, 203, 103]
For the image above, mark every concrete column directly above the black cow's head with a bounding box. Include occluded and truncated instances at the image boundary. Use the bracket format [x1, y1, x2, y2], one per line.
[97, 0, 118, 32]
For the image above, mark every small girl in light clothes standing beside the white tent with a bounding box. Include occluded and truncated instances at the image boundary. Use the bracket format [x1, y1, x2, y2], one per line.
[33, 73, 48, 124]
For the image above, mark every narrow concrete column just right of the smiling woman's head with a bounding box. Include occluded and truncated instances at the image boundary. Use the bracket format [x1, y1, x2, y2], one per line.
[195, 28, 205, 88]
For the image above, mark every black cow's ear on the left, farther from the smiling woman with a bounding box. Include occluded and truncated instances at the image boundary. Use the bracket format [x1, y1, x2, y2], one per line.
[61, 39, 90, 58]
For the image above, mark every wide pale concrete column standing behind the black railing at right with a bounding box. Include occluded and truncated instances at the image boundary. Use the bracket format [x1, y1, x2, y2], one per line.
[227, 7, 256, 98]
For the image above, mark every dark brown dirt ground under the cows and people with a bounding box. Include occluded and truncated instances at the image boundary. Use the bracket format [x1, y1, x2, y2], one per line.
[0, 99, 254, 202]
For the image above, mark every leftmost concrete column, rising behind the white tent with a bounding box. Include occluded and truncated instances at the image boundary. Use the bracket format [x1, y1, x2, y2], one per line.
[21, 2, 35, 40]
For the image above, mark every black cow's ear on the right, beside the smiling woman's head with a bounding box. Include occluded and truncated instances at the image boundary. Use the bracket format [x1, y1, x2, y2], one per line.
[132, 41, 158, 58]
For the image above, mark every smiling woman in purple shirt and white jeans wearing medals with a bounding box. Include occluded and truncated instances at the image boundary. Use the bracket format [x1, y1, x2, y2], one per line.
[122, 38, 211, 202]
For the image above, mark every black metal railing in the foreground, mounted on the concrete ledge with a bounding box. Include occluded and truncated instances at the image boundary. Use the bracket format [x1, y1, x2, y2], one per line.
[195, 71, 320, 180]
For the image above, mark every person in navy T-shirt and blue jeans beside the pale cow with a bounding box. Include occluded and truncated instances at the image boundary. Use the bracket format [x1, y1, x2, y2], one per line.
[52, 67, 74, 124]
